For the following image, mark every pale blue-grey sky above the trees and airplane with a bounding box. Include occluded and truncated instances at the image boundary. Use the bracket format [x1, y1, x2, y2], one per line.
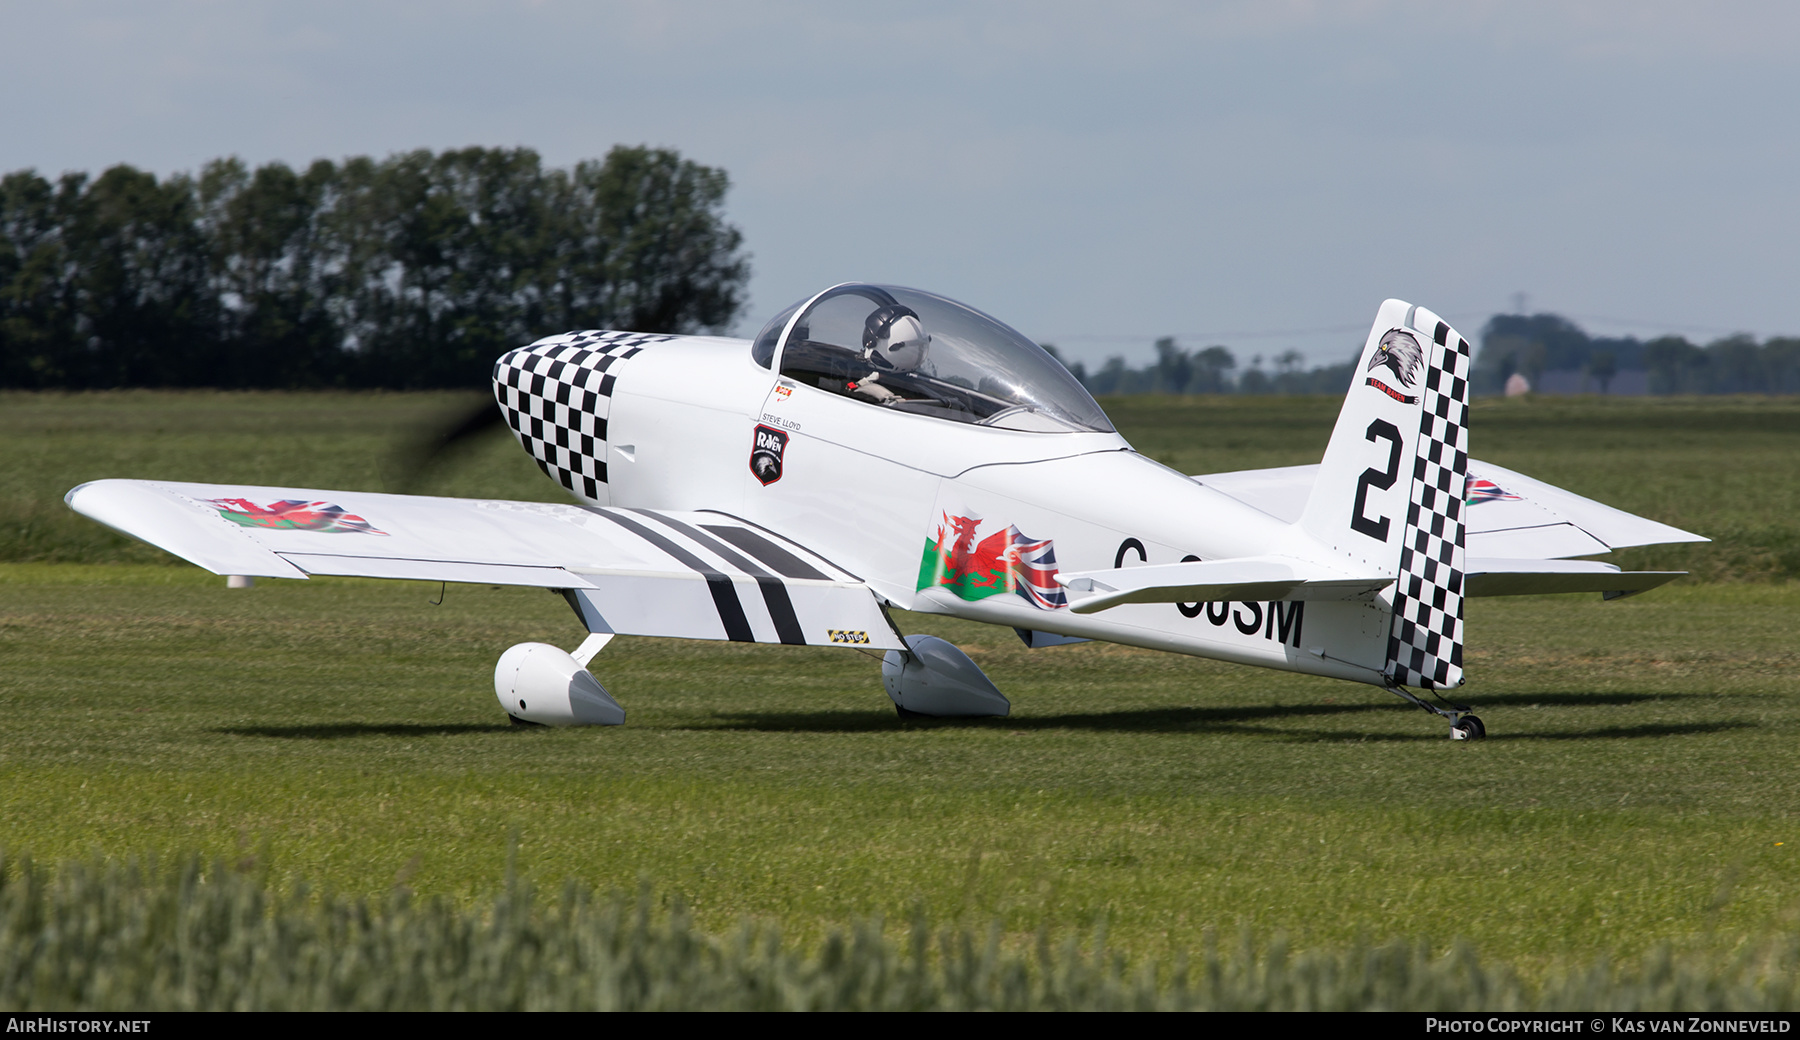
[0, 2, 1800, 368]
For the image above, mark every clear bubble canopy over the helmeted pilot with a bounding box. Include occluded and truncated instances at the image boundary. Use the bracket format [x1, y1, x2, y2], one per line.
[751, 282, 1112, 434]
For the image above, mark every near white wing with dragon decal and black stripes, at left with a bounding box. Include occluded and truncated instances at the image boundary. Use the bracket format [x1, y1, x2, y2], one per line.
[65, 480, 904, 650]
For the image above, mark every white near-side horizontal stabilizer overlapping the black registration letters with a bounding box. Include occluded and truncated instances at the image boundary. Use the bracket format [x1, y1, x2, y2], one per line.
[1058, 556, 1393, 614]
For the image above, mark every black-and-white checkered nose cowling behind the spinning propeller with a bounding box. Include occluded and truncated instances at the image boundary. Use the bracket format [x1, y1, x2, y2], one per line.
[493, 329, 675, 504]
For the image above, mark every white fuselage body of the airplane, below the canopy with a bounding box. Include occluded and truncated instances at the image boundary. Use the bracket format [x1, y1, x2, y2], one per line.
[495, 327, 1388, 682]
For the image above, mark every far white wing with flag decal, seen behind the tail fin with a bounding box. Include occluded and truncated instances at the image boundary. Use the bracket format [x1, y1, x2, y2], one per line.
[1195, 459, 1708, 560]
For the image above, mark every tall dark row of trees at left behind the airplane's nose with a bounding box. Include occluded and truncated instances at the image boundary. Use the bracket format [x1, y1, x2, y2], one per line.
[0, 146, 749, 389]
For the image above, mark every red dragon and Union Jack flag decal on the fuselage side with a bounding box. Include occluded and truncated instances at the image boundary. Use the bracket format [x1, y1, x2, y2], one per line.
[918, 509, 1069, 610]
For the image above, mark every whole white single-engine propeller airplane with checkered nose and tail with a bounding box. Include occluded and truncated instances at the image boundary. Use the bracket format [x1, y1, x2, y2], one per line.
[67, 282, 1705, 740]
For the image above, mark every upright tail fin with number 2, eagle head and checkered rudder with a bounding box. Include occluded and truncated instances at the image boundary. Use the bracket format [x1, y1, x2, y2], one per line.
[1300, 300, 1471, 689]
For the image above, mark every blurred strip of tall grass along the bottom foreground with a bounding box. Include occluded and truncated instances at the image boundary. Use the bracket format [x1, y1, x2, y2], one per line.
[0, 860, 1800, 1011]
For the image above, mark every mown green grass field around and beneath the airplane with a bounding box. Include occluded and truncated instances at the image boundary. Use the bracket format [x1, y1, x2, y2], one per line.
[0, 392, 1800, 973]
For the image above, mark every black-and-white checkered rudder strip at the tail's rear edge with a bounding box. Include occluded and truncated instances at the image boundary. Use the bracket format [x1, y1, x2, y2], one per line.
[1388, 322, 1469, 689]
